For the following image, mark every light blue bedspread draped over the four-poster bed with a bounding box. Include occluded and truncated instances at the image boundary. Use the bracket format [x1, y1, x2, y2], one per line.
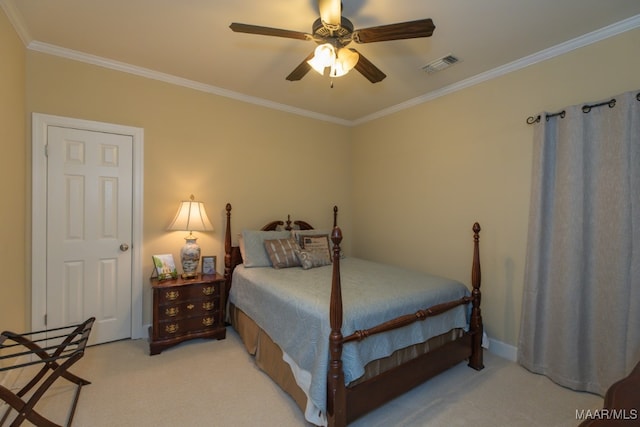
[229, 258, 469, 423]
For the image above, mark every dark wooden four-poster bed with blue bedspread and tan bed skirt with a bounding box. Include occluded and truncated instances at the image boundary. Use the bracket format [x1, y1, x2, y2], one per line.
[225, 204, 483, 426]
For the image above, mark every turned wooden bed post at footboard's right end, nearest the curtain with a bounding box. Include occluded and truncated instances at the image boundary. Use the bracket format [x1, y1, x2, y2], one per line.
[469, 222, 484, 370]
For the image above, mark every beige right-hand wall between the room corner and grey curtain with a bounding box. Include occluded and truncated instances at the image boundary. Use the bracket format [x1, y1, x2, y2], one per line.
[352, 30, 640, 345]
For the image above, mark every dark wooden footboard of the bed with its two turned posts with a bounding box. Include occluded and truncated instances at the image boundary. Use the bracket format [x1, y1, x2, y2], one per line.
[327, 222, 484, 427]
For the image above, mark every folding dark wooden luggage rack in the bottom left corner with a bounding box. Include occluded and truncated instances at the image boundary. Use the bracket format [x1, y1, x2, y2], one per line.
[0, 317, 95, 427]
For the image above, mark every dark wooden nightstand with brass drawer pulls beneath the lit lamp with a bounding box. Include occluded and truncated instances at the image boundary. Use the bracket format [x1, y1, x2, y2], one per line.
[149, 274, 227, 355]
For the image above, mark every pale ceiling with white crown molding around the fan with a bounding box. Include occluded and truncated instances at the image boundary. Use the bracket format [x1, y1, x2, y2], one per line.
[0, 0, 640, 124]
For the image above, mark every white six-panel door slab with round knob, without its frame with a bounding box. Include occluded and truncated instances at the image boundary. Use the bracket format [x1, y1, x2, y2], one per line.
[47, 126, 132, 343]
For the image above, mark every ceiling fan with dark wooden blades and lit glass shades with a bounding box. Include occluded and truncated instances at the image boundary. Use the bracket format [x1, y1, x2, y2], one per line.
[229, 0, 436, 83]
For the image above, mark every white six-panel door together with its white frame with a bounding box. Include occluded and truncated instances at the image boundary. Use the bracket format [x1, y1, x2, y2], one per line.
[32, 113, 142, 344]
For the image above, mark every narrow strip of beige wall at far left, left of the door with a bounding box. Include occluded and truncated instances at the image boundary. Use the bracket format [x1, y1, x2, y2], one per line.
[0, 9, 28, 331]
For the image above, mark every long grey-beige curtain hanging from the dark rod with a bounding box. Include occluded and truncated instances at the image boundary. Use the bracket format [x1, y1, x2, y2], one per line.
[518, 91, 640, 394]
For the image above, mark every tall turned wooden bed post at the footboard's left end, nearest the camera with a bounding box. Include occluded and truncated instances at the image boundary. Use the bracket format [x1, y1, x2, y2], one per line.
[327, 222, 347, 427]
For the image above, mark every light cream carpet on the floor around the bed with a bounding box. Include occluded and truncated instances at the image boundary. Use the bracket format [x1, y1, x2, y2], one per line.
[1, 328, 603, 427]
